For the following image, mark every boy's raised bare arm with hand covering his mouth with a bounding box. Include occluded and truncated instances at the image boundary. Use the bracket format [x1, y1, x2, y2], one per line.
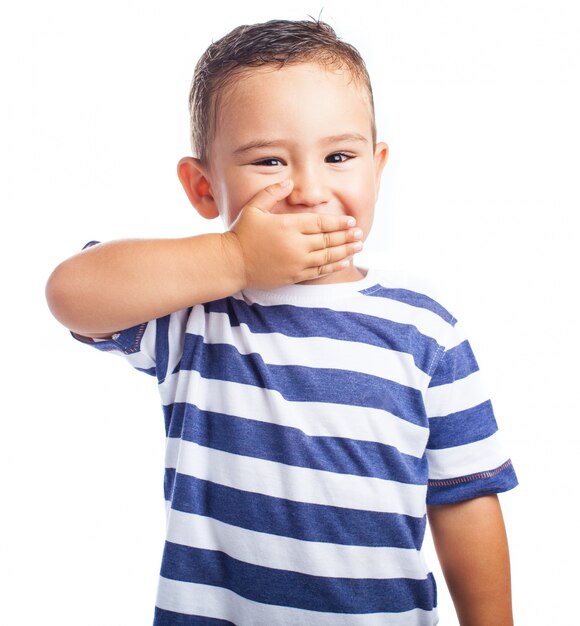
[46, 180, 356, 337]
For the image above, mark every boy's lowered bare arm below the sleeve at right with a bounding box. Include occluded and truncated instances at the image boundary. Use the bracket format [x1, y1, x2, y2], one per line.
[428, 495, 513, 626]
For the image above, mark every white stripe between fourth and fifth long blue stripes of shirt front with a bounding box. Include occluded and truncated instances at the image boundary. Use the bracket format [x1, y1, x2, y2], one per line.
[167, 509, 429, 580]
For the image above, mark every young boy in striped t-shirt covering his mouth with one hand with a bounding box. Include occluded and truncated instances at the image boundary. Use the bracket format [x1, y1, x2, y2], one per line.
[47, 21, 517, 626]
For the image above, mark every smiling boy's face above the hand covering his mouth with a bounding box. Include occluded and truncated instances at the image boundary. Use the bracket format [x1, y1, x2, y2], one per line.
[197, 63, 387, 237]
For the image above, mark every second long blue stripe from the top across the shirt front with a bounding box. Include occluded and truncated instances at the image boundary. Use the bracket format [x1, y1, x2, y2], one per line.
[180, 334, 427, 426]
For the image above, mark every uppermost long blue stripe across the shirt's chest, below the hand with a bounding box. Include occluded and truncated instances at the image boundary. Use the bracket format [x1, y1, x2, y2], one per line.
[204, 298, 439, 373]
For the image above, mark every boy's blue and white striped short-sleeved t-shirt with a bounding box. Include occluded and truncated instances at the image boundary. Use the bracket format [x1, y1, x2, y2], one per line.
[80, 272, 517, 626]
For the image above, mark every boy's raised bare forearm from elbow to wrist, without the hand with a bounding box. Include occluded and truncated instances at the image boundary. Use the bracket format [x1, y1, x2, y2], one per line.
[47, 234, 243, 336]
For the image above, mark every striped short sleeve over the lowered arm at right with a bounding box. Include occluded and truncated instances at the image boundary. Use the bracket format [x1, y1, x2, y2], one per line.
[425, 325, 518, 504]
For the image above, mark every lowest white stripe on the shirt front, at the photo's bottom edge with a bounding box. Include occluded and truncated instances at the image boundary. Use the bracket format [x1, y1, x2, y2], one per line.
[157, 577, 437, 626]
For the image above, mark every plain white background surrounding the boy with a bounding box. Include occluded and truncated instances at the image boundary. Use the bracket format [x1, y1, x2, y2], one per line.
[0, 0, 580, 626]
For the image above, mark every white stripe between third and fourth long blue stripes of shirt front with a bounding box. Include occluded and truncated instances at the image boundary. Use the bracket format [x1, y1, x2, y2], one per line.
[166, 438, 426, 517]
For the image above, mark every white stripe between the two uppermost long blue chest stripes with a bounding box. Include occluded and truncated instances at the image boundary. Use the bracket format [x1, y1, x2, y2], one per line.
[194, 313, 430, 389]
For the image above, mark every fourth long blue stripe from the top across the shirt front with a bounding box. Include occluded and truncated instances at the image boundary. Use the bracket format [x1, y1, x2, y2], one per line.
[165, 469, 425, 550]
